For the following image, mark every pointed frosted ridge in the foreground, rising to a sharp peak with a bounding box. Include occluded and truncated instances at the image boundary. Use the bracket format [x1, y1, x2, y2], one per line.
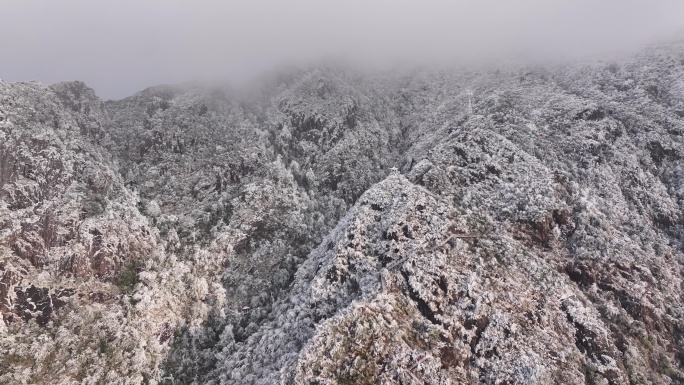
[207, 170, 672, 384]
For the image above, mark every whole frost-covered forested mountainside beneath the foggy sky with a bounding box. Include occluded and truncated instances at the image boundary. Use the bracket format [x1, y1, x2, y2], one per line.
[0, 39, 684, 385]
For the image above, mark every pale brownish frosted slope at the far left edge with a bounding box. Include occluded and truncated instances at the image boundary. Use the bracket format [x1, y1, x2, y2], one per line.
[0, 82, 174, 383]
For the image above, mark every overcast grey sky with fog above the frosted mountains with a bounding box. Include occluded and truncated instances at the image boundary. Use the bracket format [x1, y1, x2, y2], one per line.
[0, 0, 684, 99]
